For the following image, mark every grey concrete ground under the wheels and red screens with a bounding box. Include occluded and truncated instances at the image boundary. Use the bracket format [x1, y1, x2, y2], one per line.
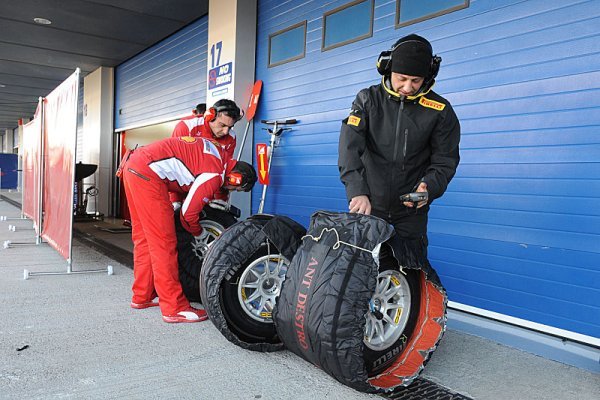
[0, 192, 600, 400]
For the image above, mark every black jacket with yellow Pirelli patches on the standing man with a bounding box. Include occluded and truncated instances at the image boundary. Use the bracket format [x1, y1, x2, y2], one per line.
[338, 83, 460, 225]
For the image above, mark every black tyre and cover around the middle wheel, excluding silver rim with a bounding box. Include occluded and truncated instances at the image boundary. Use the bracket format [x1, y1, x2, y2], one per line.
[200, 215, 306, 352]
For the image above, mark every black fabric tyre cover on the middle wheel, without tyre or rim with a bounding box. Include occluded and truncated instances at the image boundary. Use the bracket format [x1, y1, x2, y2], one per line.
[200, 214, 306, 352]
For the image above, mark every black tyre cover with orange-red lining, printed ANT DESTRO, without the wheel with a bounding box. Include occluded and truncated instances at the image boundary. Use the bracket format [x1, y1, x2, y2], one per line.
[273, 211, 446, 393]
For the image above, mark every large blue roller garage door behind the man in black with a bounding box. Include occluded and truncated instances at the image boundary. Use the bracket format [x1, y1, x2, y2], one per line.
[253, 0, 600, 338]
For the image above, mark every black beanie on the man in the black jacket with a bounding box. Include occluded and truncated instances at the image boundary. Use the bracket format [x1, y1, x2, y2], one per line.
[392, 34, 433, 78]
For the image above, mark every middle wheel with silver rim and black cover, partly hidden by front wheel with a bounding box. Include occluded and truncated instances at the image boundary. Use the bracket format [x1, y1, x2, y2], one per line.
[200, 214, 306, 352]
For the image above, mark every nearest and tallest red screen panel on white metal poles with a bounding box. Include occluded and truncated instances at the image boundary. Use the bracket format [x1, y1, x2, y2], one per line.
[42, 69, 79, 260]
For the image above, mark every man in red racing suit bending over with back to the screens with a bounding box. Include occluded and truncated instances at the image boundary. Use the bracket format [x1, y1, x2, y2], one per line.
[120, 137, 256, 323]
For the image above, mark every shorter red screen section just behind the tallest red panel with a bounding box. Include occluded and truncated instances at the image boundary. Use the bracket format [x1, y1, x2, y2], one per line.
[22, 99, 42, 235]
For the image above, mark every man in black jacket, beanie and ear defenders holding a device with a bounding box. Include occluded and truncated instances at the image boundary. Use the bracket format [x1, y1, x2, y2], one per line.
[338, 34, 460, 241]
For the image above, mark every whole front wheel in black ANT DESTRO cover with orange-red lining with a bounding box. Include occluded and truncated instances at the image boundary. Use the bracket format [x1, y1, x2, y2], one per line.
[273, 211, 447, 393]
